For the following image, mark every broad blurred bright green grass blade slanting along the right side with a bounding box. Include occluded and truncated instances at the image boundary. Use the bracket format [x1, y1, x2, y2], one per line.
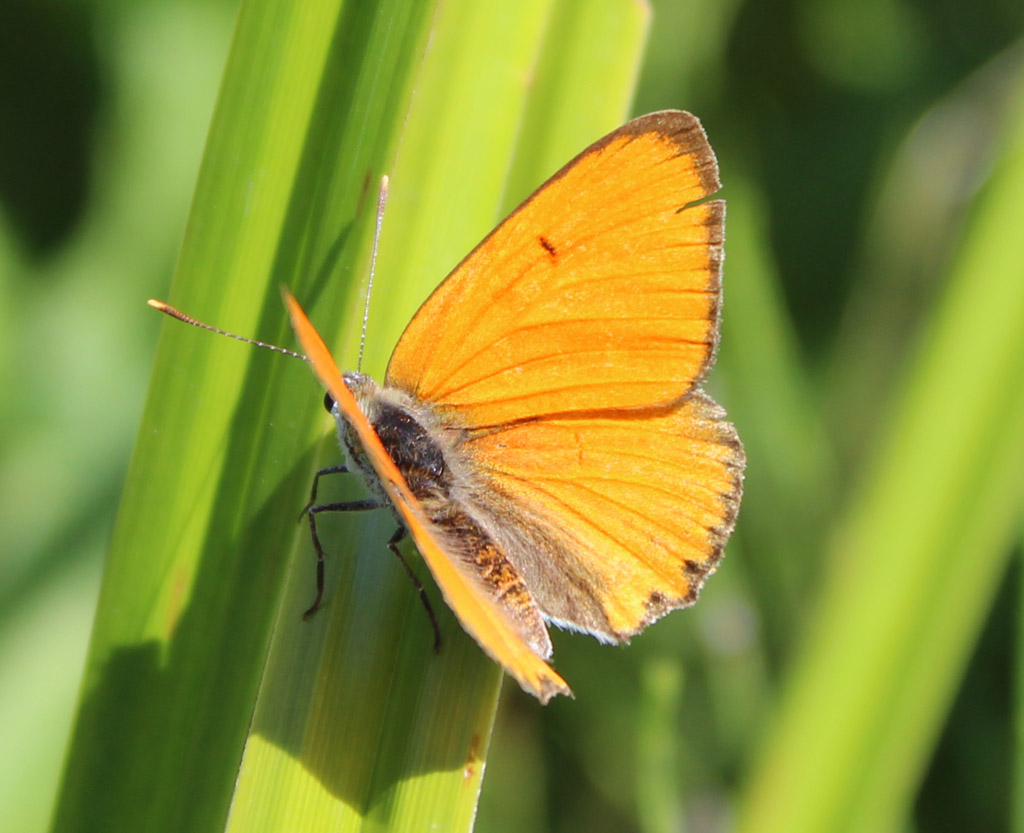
[739, 61, 1024, 833]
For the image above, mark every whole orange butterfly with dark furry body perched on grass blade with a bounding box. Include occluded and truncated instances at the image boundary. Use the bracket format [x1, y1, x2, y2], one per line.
[151, 111, 745, 703]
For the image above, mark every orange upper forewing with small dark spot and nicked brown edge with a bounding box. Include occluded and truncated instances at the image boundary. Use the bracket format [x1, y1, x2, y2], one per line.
[385, 111, 725, 426]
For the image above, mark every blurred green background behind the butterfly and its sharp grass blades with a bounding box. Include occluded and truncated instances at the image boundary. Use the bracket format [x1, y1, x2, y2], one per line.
[0, 0, 1024, 831]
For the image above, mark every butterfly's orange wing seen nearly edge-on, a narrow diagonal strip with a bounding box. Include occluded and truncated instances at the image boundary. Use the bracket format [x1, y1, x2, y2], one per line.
[284, 291, 571, 703]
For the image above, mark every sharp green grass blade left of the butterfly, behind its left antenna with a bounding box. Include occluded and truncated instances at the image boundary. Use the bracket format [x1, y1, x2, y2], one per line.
[55, 2, 440, 830]
